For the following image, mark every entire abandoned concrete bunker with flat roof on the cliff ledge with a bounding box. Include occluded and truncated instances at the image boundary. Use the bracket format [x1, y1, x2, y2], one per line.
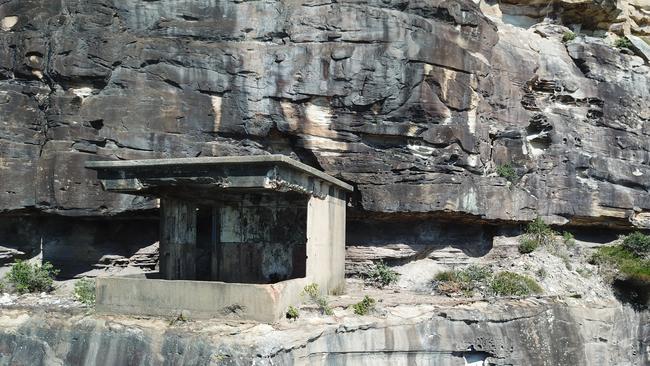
[86, 155, 352, 321]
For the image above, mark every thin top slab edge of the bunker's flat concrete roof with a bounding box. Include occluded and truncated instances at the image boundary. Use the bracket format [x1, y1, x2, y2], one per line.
[86, 155, 354, 192]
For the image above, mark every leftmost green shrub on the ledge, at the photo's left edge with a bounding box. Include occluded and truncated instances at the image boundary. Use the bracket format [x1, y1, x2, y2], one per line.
[6, 260, 59, 294]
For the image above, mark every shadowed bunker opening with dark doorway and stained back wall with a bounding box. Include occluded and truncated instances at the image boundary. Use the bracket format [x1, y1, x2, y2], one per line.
[196, 193, 308, 284]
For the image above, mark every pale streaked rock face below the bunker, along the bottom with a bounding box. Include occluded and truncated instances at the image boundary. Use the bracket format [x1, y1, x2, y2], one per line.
[0, 299, 650, 366]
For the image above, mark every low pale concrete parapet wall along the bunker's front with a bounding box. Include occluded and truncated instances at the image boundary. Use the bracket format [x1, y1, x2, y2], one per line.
[96, 277, 308, 323]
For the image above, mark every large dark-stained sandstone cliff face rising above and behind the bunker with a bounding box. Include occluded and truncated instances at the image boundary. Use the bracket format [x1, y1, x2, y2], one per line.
[0, 0, 650, 228]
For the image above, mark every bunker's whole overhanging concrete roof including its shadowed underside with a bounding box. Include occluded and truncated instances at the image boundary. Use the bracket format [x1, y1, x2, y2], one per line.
[85, 155, 353, 197]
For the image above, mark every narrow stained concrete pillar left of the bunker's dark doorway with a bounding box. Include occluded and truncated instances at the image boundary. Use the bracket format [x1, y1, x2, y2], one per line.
[160, 198, 196, 280]
